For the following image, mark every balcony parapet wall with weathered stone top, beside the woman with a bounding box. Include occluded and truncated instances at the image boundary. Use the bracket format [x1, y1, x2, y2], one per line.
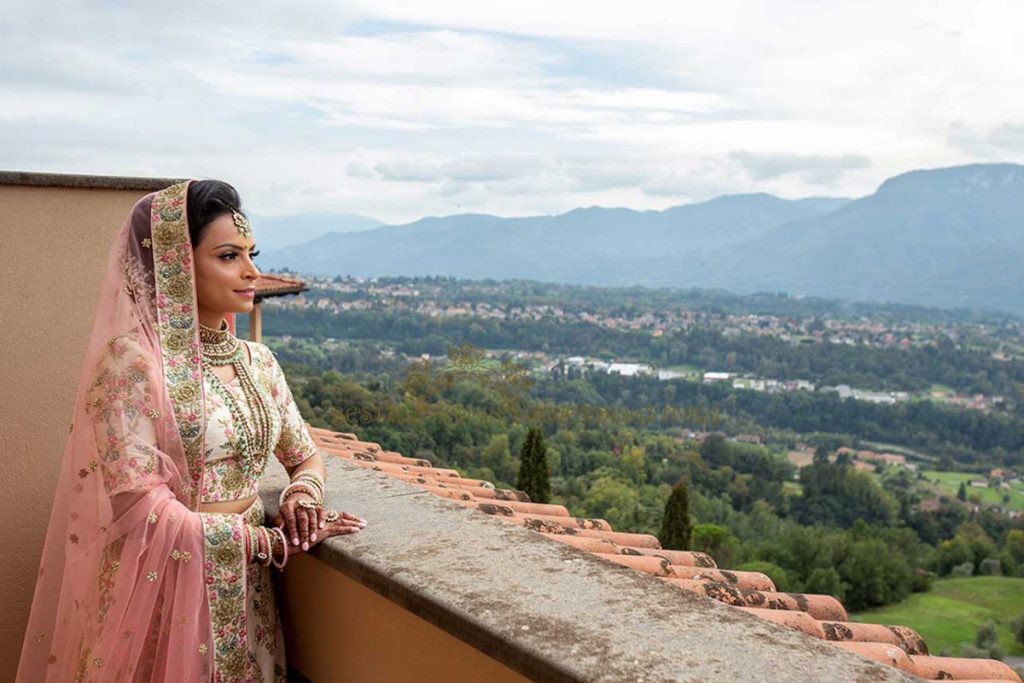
[260, 455, 914, 683]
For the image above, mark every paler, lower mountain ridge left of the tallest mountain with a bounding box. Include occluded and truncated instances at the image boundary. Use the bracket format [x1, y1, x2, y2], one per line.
[263, 195, 848, 285]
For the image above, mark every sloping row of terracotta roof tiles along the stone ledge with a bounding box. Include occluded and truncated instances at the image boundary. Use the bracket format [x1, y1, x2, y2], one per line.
[309, 427, 1024, 683]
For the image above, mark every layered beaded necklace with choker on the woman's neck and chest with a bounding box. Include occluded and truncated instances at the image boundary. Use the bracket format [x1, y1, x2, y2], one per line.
[199, 323, 272, 478]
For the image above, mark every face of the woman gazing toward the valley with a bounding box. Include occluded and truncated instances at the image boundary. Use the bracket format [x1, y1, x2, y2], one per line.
[193, 213, 259, 327]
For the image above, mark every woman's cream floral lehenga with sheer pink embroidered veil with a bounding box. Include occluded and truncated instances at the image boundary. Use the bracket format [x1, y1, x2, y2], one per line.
[17, 182, 316, 683]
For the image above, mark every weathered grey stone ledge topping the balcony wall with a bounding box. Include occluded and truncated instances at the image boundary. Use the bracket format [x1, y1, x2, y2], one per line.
[260, 454, 916, 681]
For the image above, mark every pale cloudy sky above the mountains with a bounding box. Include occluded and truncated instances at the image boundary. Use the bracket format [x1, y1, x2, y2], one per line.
[0, 0, 1024, 222]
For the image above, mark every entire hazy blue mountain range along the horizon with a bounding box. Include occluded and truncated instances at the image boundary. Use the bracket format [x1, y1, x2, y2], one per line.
[261, 164, 1024, 314]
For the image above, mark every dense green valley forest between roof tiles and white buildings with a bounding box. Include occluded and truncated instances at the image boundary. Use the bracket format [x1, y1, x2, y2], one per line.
[274, 340, 1024, 610]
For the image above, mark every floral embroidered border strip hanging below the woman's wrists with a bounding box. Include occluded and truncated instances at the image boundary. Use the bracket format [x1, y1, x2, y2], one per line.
[201, 513, 249, 683]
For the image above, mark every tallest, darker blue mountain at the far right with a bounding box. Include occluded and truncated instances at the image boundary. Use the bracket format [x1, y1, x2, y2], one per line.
[692, 164, 1024, 313]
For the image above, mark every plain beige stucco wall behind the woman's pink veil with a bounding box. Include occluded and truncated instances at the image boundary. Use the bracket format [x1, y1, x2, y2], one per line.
[0, 182, 163, 681]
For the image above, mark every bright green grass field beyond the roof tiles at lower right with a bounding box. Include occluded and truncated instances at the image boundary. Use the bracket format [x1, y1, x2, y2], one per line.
[850, 577, 1024, 656]
